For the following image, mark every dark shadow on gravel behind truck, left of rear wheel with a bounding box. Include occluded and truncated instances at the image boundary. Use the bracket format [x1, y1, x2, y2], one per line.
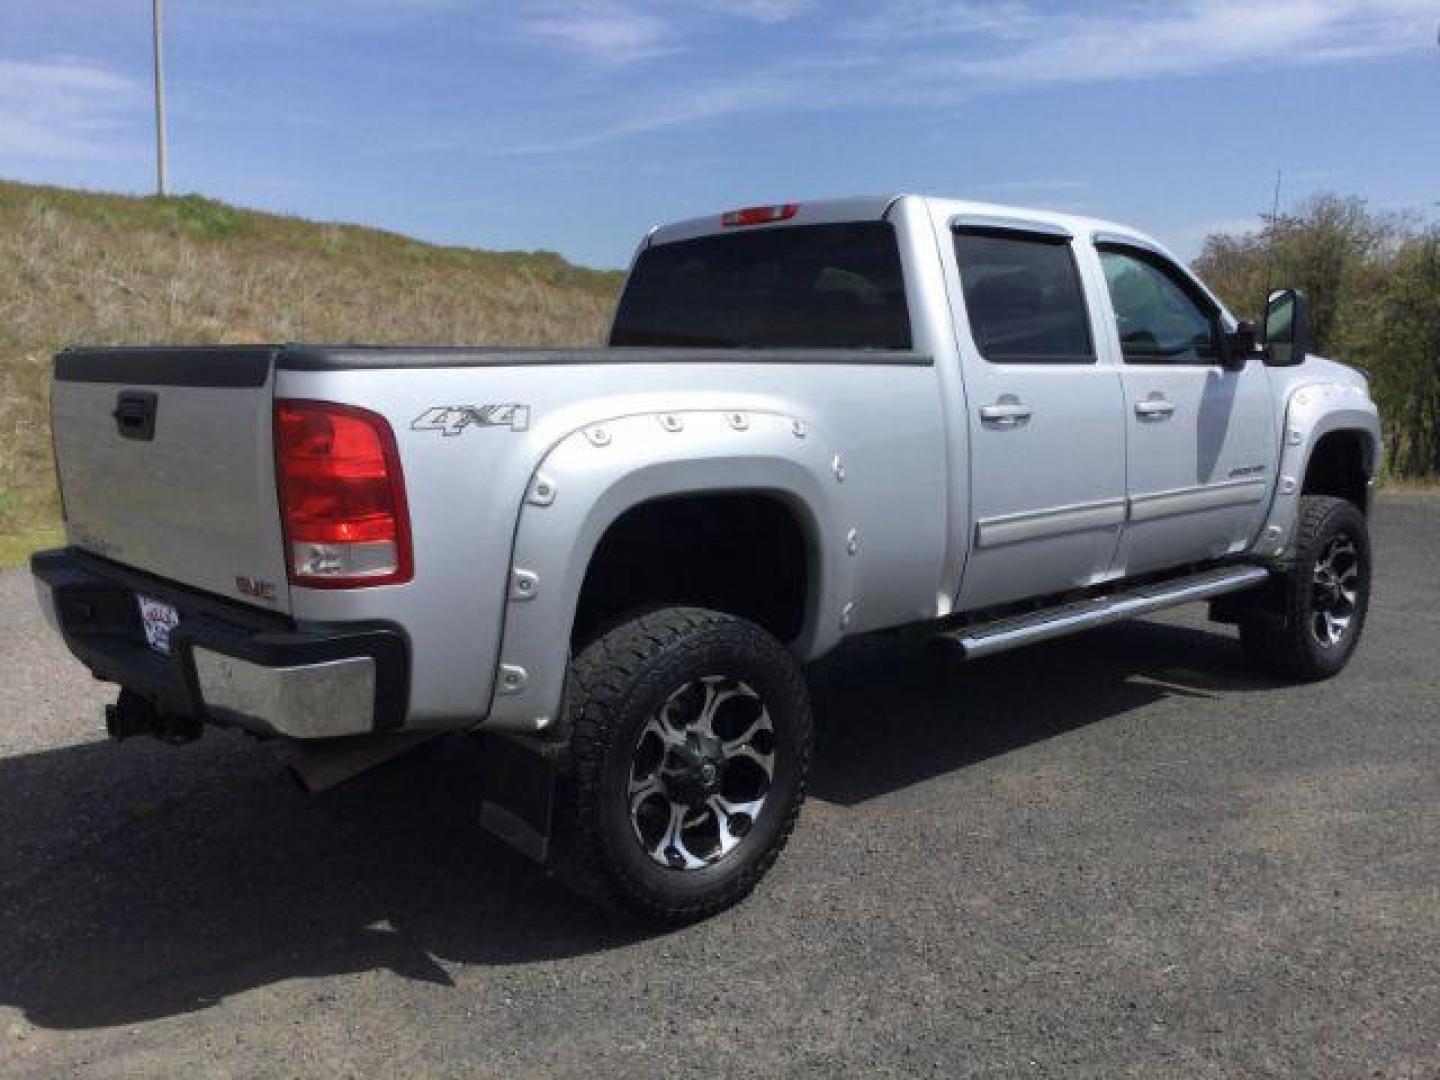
[0, 733, 636, 1028]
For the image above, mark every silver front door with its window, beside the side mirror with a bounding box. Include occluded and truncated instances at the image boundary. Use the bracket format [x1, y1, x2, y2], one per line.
[1096, 238, 1277, 575]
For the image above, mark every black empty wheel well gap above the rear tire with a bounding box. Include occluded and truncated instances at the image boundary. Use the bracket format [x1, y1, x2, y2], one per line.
[570, 492, 811, 645]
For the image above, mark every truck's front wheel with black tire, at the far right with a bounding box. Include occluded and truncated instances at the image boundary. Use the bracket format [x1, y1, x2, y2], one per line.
[1240, 495, 1371, 681]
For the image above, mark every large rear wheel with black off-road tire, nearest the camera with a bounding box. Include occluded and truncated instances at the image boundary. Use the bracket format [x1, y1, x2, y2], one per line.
[556, 608, 812, 923]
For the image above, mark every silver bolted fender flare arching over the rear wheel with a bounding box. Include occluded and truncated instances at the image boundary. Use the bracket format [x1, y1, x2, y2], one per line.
[481, 410, 855, 733]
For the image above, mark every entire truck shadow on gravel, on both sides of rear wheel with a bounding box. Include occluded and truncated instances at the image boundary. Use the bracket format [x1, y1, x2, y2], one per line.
[0, 624, 1264, 1028]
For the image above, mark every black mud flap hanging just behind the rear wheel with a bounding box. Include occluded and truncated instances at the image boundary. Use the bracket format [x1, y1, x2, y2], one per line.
[480, 733, 563, 864]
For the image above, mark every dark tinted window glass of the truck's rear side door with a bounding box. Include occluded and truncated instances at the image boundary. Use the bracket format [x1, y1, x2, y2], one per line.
[955, 229, 1094, 364]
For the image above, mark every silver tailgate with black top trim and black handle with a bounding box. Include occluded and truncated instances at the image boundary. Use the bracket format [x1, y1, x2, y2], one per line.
[52, 346, 289, 611]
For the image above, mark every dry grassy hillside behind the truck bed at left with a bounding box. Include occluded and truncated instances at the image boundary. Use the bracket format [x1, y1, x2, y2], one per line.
[0, 181, 619, 564]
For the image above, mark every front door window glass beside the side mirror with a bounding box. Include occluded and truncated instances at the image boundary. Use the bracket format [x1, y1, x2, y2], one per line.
[1100, 248, 1220, 364]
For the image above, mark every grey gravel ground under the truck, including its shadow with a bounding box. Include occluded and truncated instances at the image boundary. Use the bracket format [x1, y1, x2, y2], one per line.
[0, 495, 1440, 1077]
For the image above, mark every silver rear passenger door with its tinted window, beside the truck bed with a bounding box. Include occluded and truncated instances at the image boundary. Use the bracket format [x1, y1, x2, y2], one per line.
[948, 215, 1125, 609]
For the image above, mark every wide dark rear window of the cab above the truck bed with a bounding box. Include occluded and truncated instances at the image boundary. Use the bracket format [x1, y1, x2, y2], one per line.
[611, 222, 912, 350]
